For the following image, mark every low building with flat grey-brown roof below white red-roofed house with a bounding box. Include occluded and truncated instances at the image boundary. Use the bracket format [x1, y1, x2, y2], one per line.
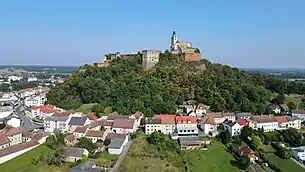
[179, 136, 202, 150]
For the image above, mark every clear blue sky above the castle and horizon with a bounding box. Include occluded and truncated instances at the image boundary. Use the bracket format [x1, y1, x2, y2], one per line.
[0, 0, 305, 68]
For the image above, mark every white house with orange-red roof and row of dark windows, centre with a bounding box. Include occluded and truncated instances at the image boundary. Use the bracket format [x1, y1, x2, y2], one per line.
[175, 116, 198, 136]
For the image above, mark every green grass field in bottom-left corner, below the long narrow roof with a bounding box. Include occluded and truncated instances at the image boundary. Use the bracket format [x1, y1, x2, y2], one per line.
[0, 145, 69, 172]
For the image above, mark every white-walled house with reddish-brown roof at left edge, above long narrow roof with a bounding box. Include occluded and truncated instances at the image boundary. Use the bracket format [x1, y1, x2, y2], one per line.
[0, 126, 22, 149]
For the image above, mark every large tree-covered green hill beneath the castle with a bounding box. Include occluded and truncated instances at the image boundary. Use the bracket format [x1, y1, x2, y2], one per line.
[47, 53, 305, 115]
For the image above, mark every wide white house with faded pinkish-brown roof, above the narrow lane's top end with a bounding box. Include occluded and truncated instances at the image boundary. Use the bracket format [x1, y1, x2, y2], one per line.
[112, 119, 137, 134]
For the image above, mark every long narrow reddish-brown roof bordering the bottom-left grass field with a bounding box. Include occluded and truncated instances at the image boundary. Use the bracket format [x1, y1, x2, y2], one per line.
[0, 140, 39, 157]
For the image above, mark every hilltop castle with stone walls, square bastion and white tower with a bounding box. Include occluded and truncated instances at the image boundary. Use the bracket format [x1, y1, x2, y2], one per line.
[94, 30, 201, 69]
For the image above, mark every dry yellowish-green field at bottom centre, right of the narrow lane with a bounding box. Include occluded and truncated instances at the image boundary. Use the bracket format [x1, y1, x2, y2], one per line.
[118, 134, 185, 172]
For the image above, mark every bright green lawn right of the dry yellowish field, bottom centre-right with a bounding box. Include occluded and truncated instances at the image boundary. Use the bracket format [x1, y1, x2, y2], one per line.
[185, 141, 241, 172]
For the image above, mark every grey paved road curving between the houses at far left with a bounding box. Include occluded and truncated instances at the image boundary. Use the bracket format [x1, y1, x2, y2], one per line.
[15, 101, 43, 131]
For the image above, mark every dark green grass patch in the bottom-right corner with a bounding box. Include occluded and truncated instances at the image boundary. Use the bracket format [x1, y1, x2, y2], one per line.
[266, 153, 305, 172]
